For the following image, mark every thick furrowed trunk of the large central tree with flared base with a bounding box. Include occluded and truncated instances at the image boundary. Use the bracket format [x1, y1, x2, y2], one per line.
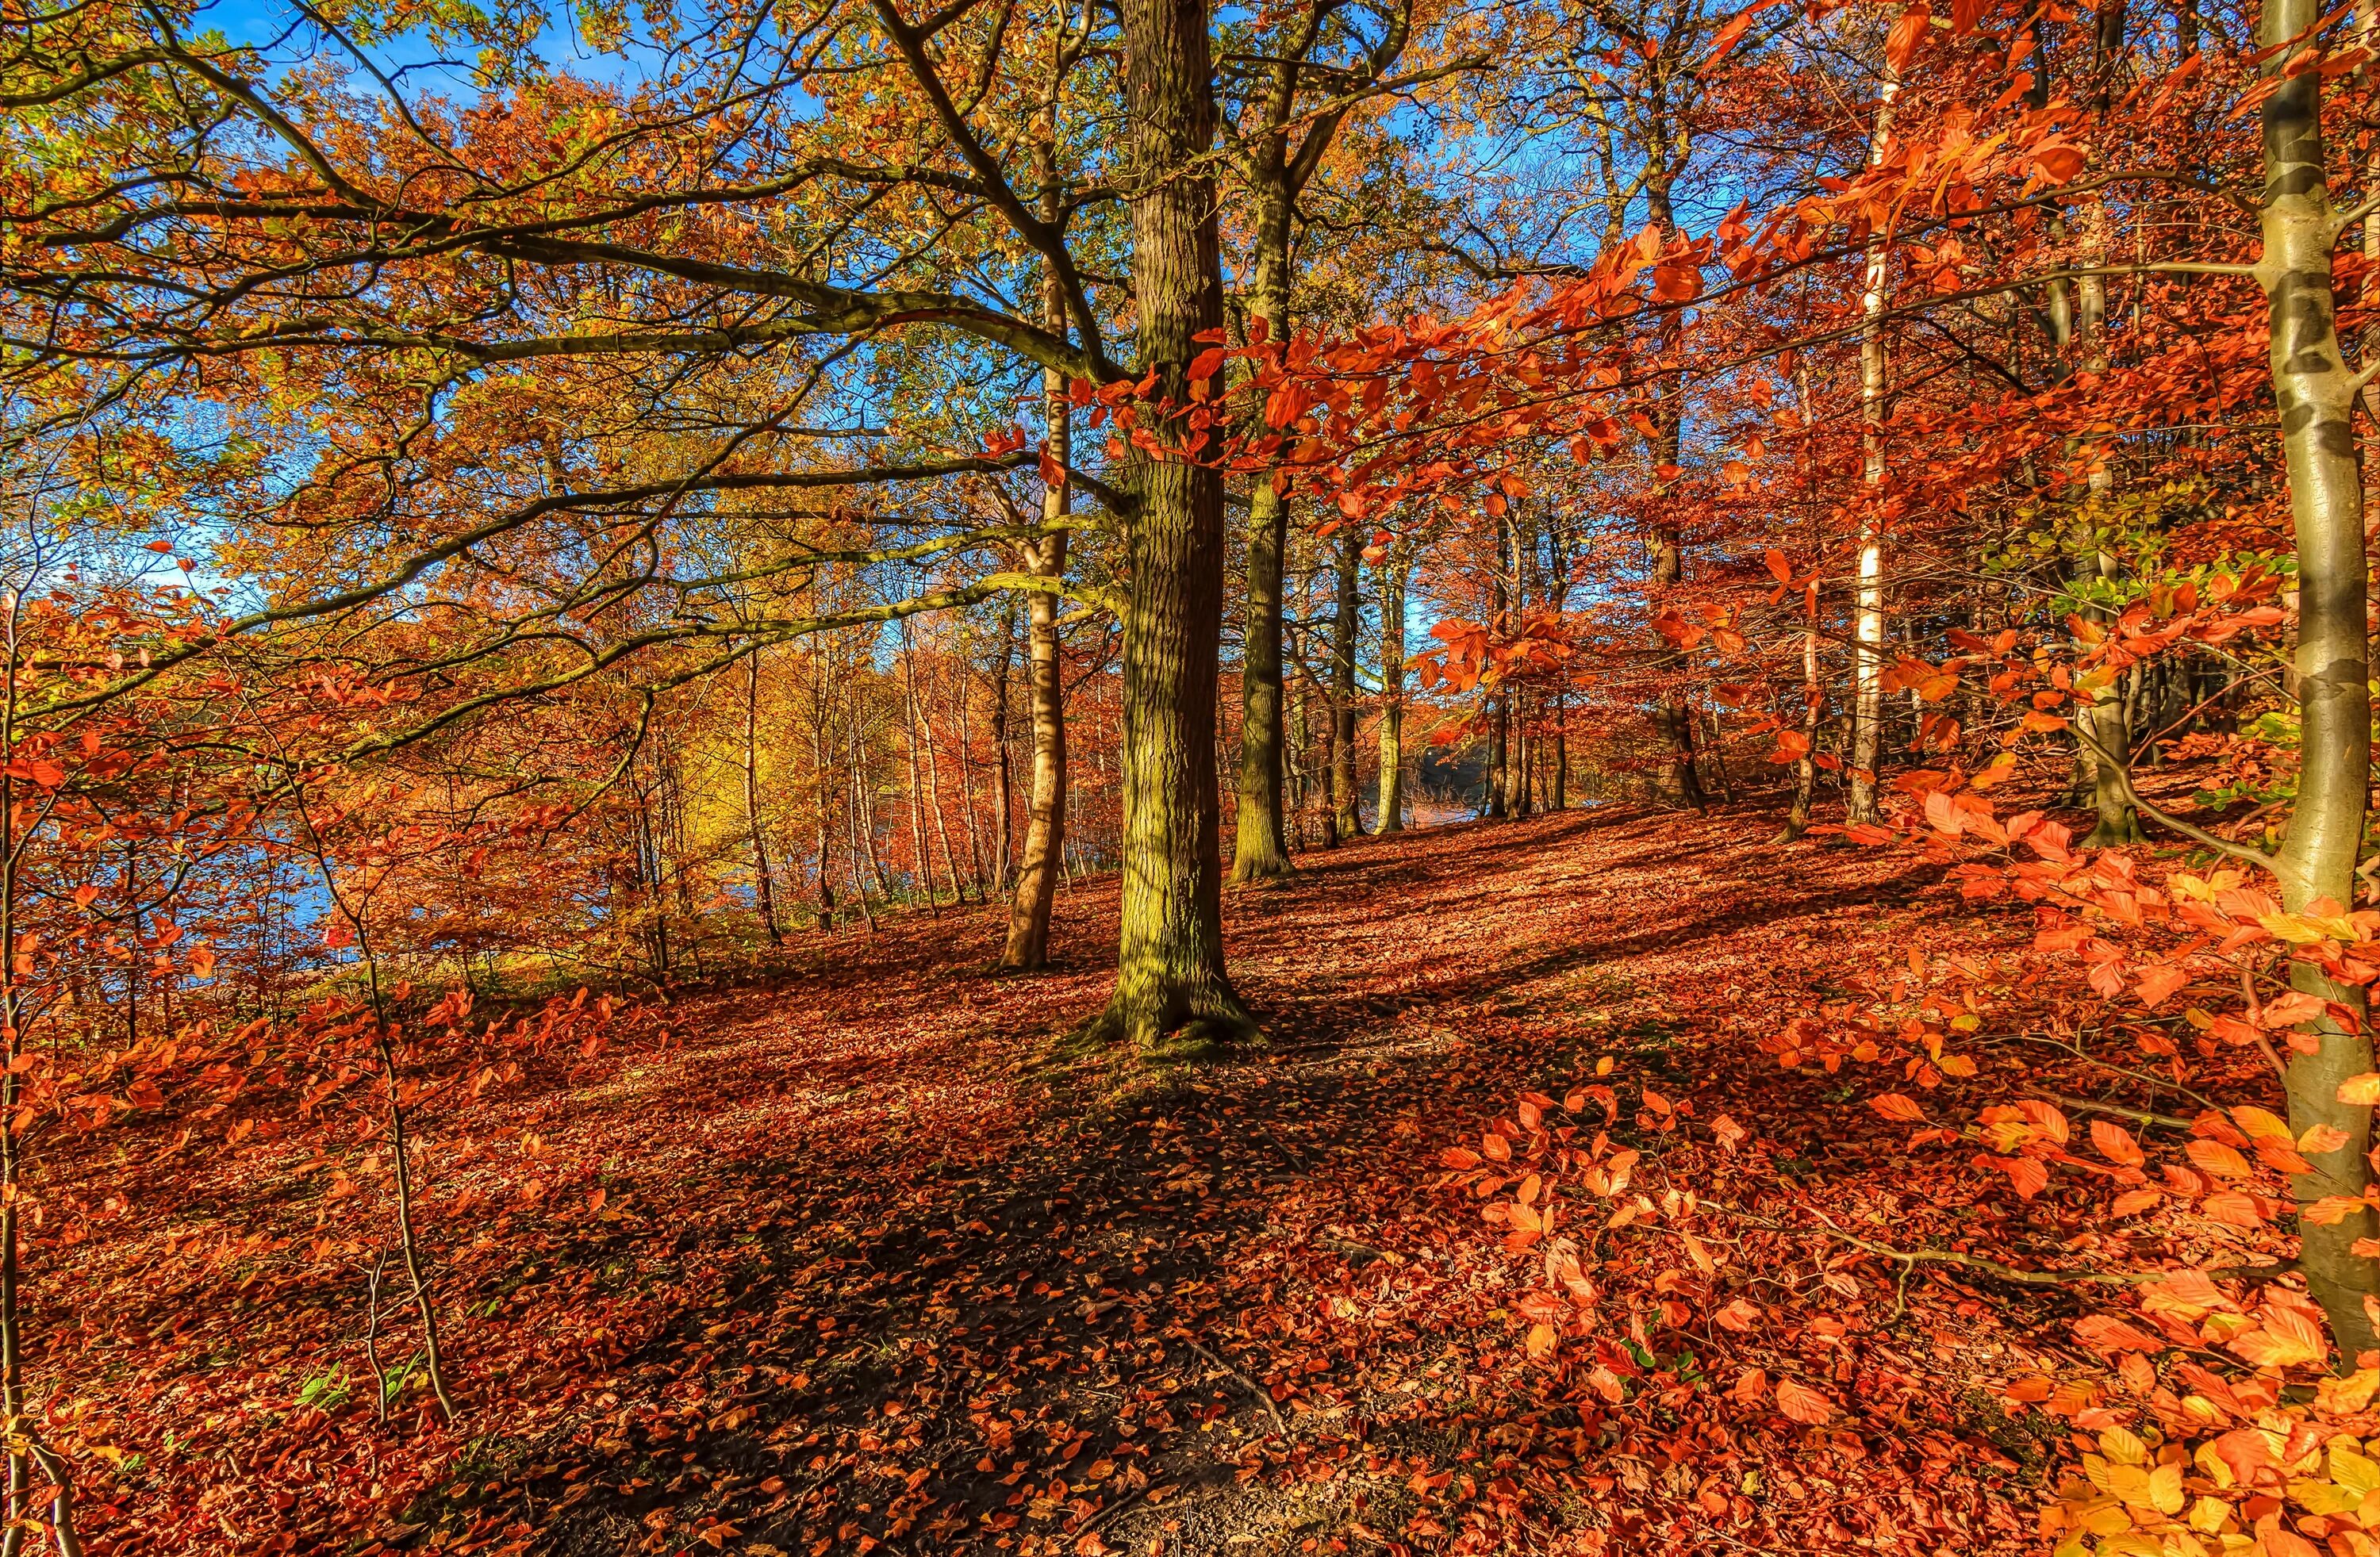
[1097, 0, 1257, 1055]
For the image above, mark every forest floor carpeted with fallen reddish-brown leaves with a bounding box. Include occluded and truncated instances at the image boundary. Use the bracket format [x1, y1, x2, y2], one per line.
[36, 805, 2161, 1557]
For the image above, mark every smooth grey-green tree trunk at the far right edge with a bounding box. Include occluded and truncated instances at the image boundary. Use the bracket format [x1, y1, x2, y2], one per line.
[2256, 0, 2380, 1367]
